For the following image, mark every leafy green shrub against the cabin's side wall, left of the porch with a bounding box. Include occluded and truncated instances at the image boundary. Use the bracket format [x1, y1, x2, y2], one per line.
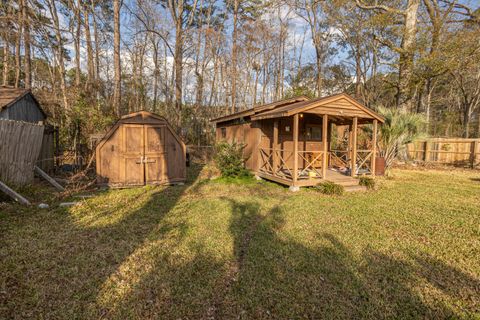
[213, 141, 250, 177]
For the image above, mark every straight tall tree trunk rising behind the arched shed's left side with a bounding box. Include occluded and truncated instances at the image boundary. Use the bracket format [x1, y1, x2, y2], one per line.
[113, 0, 122, 117]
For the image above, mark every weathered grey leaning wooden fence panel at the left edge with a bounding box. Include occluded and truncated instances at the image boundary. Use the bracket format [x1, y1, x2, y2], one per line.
[0, 120, 44, 185]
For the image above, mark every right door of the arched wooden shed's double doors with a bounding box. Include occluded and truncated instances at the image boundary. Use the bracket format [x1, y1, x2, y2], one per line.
[144, 125, 168, 184]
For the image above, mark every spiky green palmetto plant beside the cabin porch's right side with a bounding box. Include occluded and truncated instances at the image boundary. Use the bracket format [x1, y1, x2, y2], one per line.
[377, 107, 425, 169]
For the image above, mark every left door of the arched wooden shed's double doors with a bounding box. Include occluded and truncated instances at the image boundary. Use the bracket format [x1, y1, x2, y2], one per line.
[123, 124, 145, 186]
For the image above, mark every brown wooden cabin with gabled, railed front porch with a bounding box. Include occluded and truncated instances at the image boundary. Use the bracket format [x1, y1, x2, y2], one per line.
[212, 93, 384, 190]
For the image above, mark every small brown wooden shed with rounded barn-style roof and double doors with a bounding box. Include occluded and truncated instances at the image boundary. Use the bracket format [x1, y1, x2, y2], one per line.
[96, 111, 186, 187]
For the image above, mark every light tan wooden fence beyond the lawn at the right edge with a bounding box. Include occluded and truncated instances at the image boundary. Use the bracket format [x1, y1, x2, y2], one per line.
[407, 138, 480, 168]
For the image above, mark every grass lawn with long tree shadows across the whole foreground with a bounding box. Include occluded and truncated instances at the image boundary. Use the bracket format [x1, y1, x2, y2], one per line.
[0, 167, 480, 319]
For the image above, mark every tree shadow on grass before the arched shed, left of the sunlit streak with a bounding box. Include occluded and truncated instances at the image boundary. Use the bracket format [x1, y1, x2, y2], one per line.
[0, 166, 201, 319]
